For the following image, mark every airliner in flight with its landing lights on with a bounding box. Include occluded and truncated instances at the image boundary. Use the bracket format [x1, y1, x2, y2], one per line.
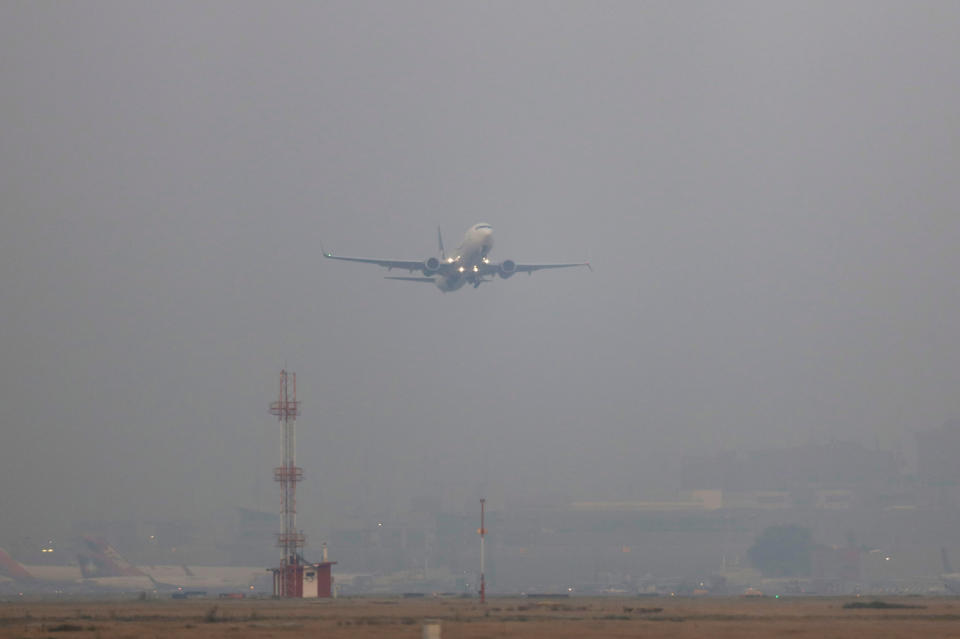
[323, 222, 593, 293]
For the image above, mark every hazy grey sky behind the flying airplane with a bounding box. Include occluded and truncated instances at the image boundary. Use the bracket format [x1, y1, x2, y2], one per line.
[0, 0, 960, 534]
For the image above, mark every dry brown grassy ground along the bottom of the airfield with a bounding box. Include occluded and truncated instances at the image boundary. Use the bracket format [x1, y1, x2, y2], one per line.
[0, 597, 960, 639]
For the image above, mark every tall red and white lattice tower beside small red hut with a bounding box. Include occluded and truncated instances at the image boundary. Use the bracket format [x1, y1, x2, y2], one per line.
[270, 370, 306, 597]
